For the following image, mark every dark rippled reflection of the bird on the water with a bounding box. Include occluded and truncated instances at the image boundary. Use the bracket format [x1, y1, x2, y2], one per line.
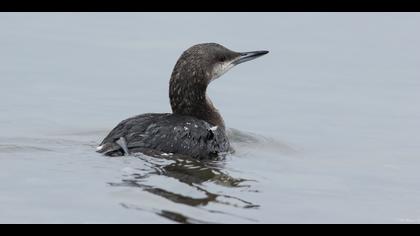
[110, 150, 259, 223]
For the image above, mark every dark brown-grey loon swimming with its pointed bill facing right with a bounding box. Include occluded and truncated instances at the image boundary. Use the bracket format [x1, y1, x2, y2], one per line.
[97, 43, 268, 159]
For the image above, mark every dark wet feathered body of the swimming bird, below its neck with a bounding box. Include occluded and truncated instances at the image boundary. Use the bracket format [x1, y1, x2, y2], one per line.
[98, 113, 230, 159]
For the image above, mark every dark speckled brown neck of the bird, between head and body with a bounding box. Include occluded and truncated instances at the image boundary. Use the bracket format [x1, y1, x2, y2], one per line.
[169, 78, 225, 129]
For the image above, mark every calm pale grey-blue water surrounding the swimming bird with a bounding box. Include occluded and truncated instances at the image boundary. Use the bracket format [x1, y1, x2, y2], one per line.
[0, 13, 420, 223]
